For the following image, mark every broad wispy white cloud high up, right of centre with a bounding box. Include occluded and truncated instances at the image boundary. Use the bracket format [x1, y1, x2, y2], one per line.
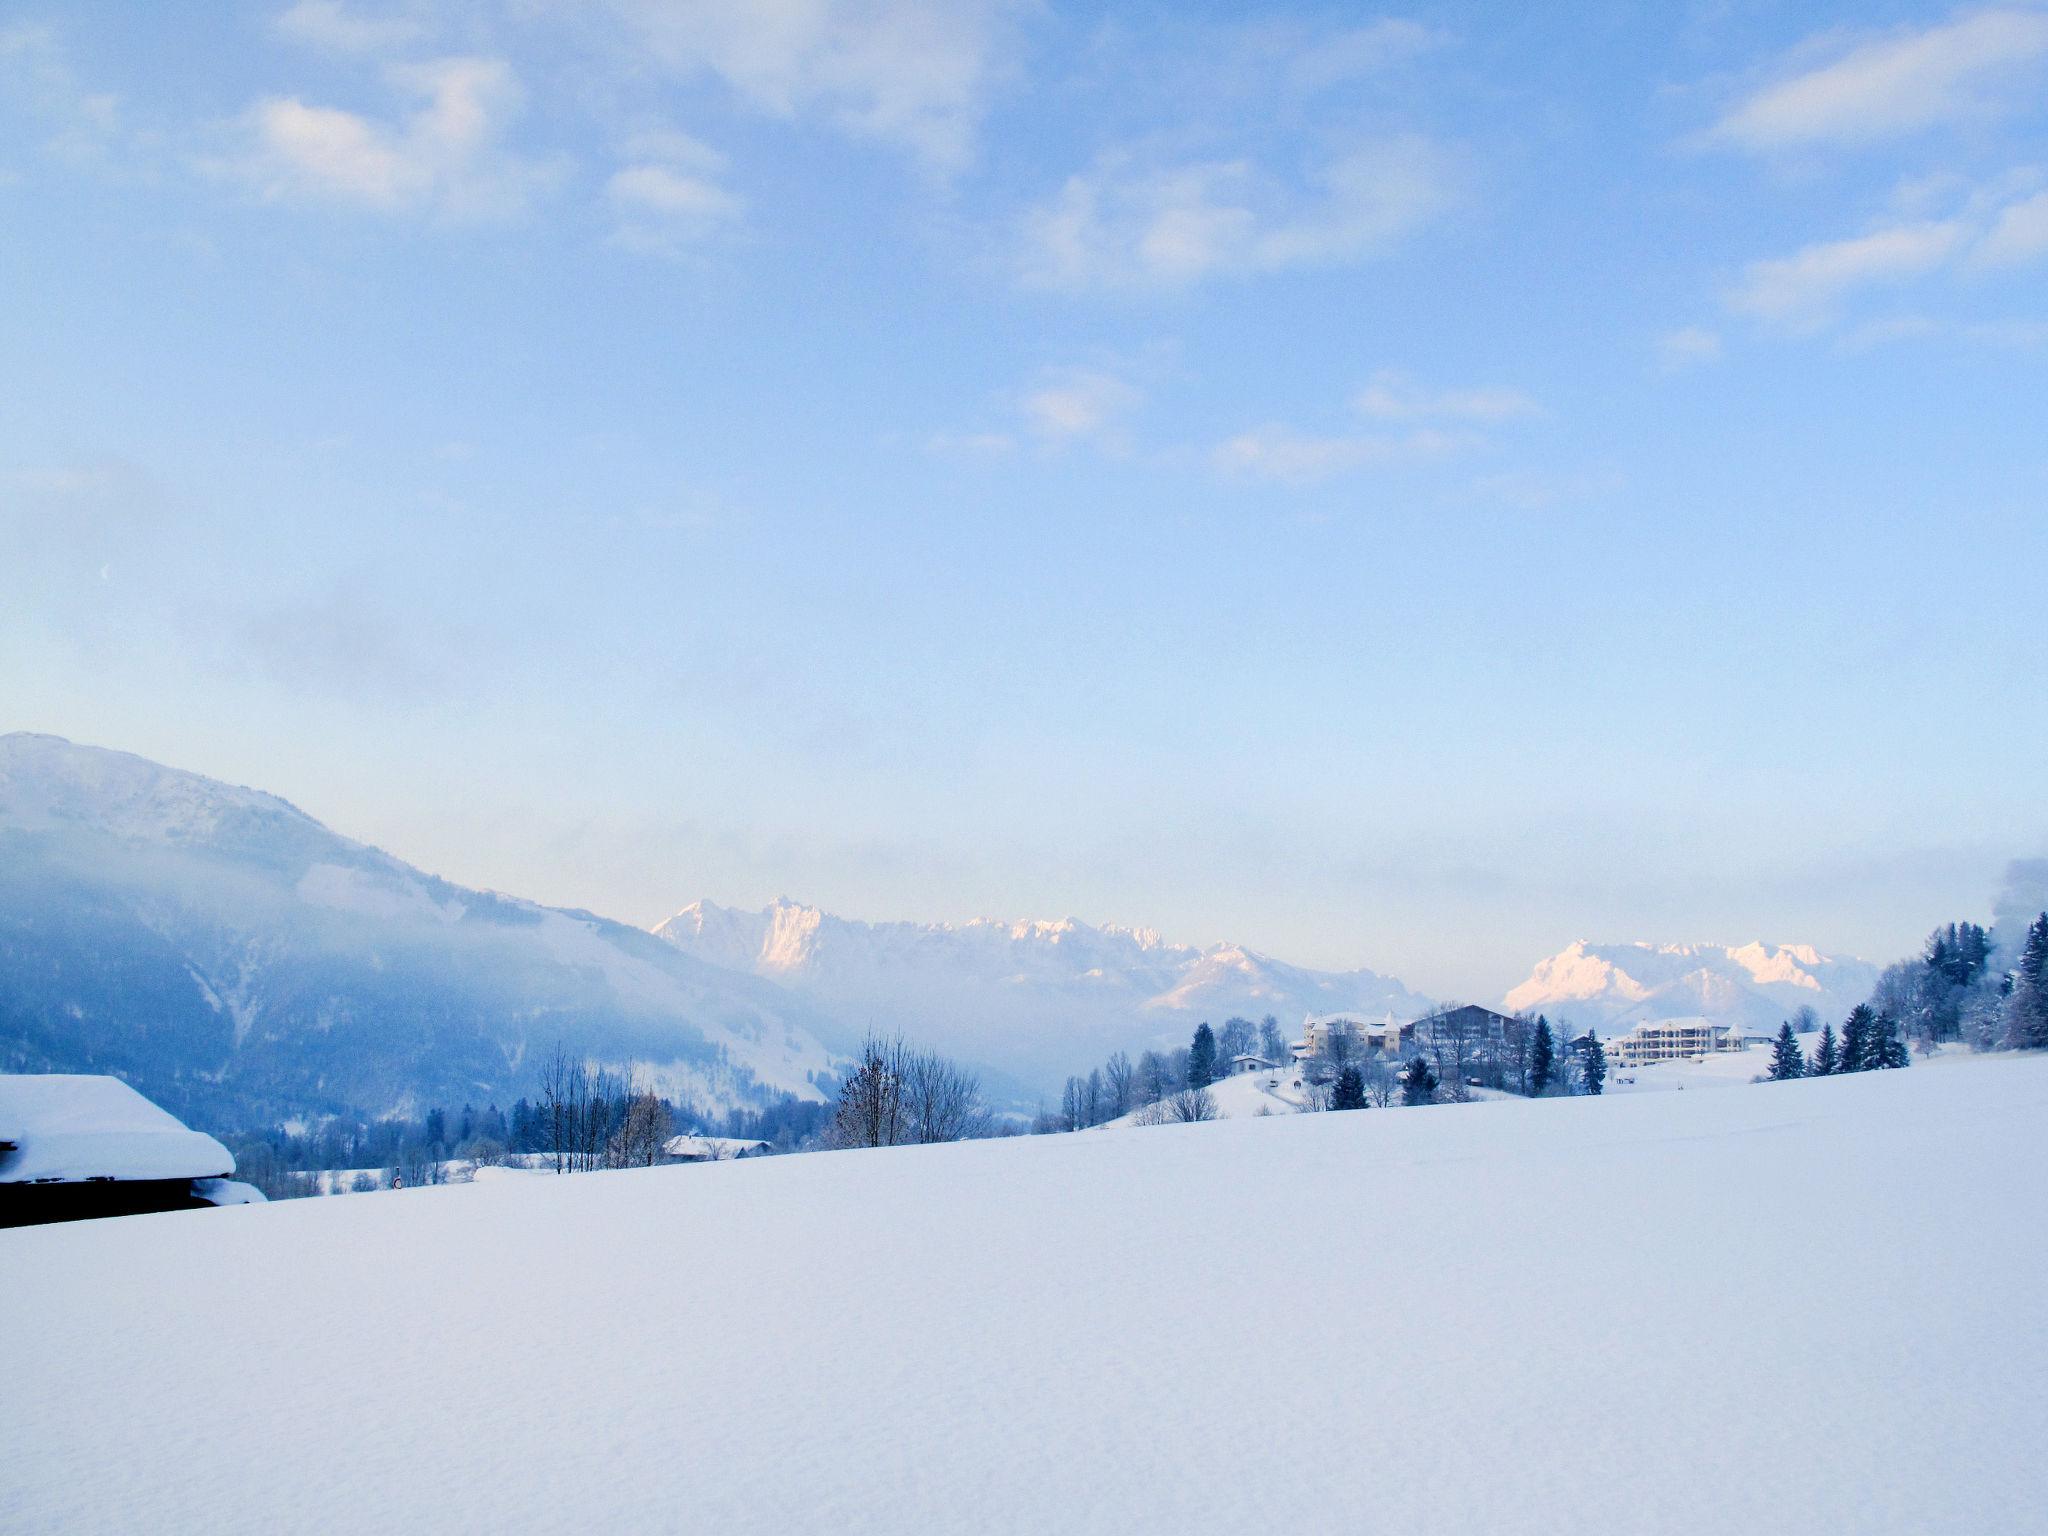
[1022, 137, 1452, 289]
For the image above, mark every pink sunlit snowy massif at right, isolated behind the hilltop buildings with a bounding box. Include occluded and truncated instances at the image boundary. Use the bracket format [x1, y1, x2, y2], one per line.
[1505, 940, 1878, 1032]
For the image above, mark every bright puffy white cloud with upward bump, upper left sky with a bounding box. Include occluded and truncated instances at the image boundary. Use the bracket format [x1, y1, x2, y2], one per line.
[229, 57, 555, 219]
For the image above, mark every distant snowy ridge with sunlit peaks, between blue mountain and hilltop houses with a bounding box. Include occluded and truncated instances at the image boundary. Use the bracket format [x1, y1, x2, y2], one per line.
[655, 901, 1427, 1087]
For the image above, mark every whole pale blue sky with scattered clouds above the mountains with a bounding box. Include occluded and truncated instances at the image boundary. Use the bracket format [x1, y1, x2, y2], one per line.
[0, 0, 2048, 997]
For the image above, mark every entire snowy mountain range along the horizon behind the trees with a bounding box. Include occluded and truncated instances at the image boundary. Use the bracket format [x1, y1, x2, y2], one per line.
[0, 733, 1876, 1126]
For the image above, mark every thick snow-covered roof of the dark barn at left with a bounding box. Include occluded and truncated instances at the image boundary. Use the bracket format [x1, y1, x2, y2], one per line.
[0, 1073, 236, 1184]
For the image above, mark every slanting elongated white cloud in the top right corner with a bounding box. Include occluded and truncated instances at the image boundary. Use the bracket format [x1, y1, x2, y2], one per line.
[1714, 10, 2048, 150]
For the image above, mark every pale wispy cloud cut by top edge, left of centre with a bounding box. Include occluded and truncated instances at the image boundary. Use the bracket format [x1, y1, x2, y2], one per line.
[614, 0, 1020, 172]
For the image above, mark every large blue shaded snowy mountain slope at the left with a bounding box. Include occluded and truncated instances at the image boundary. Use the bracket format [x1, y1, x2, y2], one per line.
[0, 733, 831, 1124]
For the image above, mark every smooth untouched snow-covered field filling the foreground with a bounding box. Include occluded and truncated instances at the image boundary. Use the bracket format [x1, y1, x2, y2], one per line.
[0, 1059, 2048, 1536]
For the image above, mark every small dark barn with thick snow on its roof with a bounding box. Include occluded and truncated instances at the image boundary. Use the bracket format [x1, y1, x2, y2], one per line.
[0, 1073, 262, 1227]
